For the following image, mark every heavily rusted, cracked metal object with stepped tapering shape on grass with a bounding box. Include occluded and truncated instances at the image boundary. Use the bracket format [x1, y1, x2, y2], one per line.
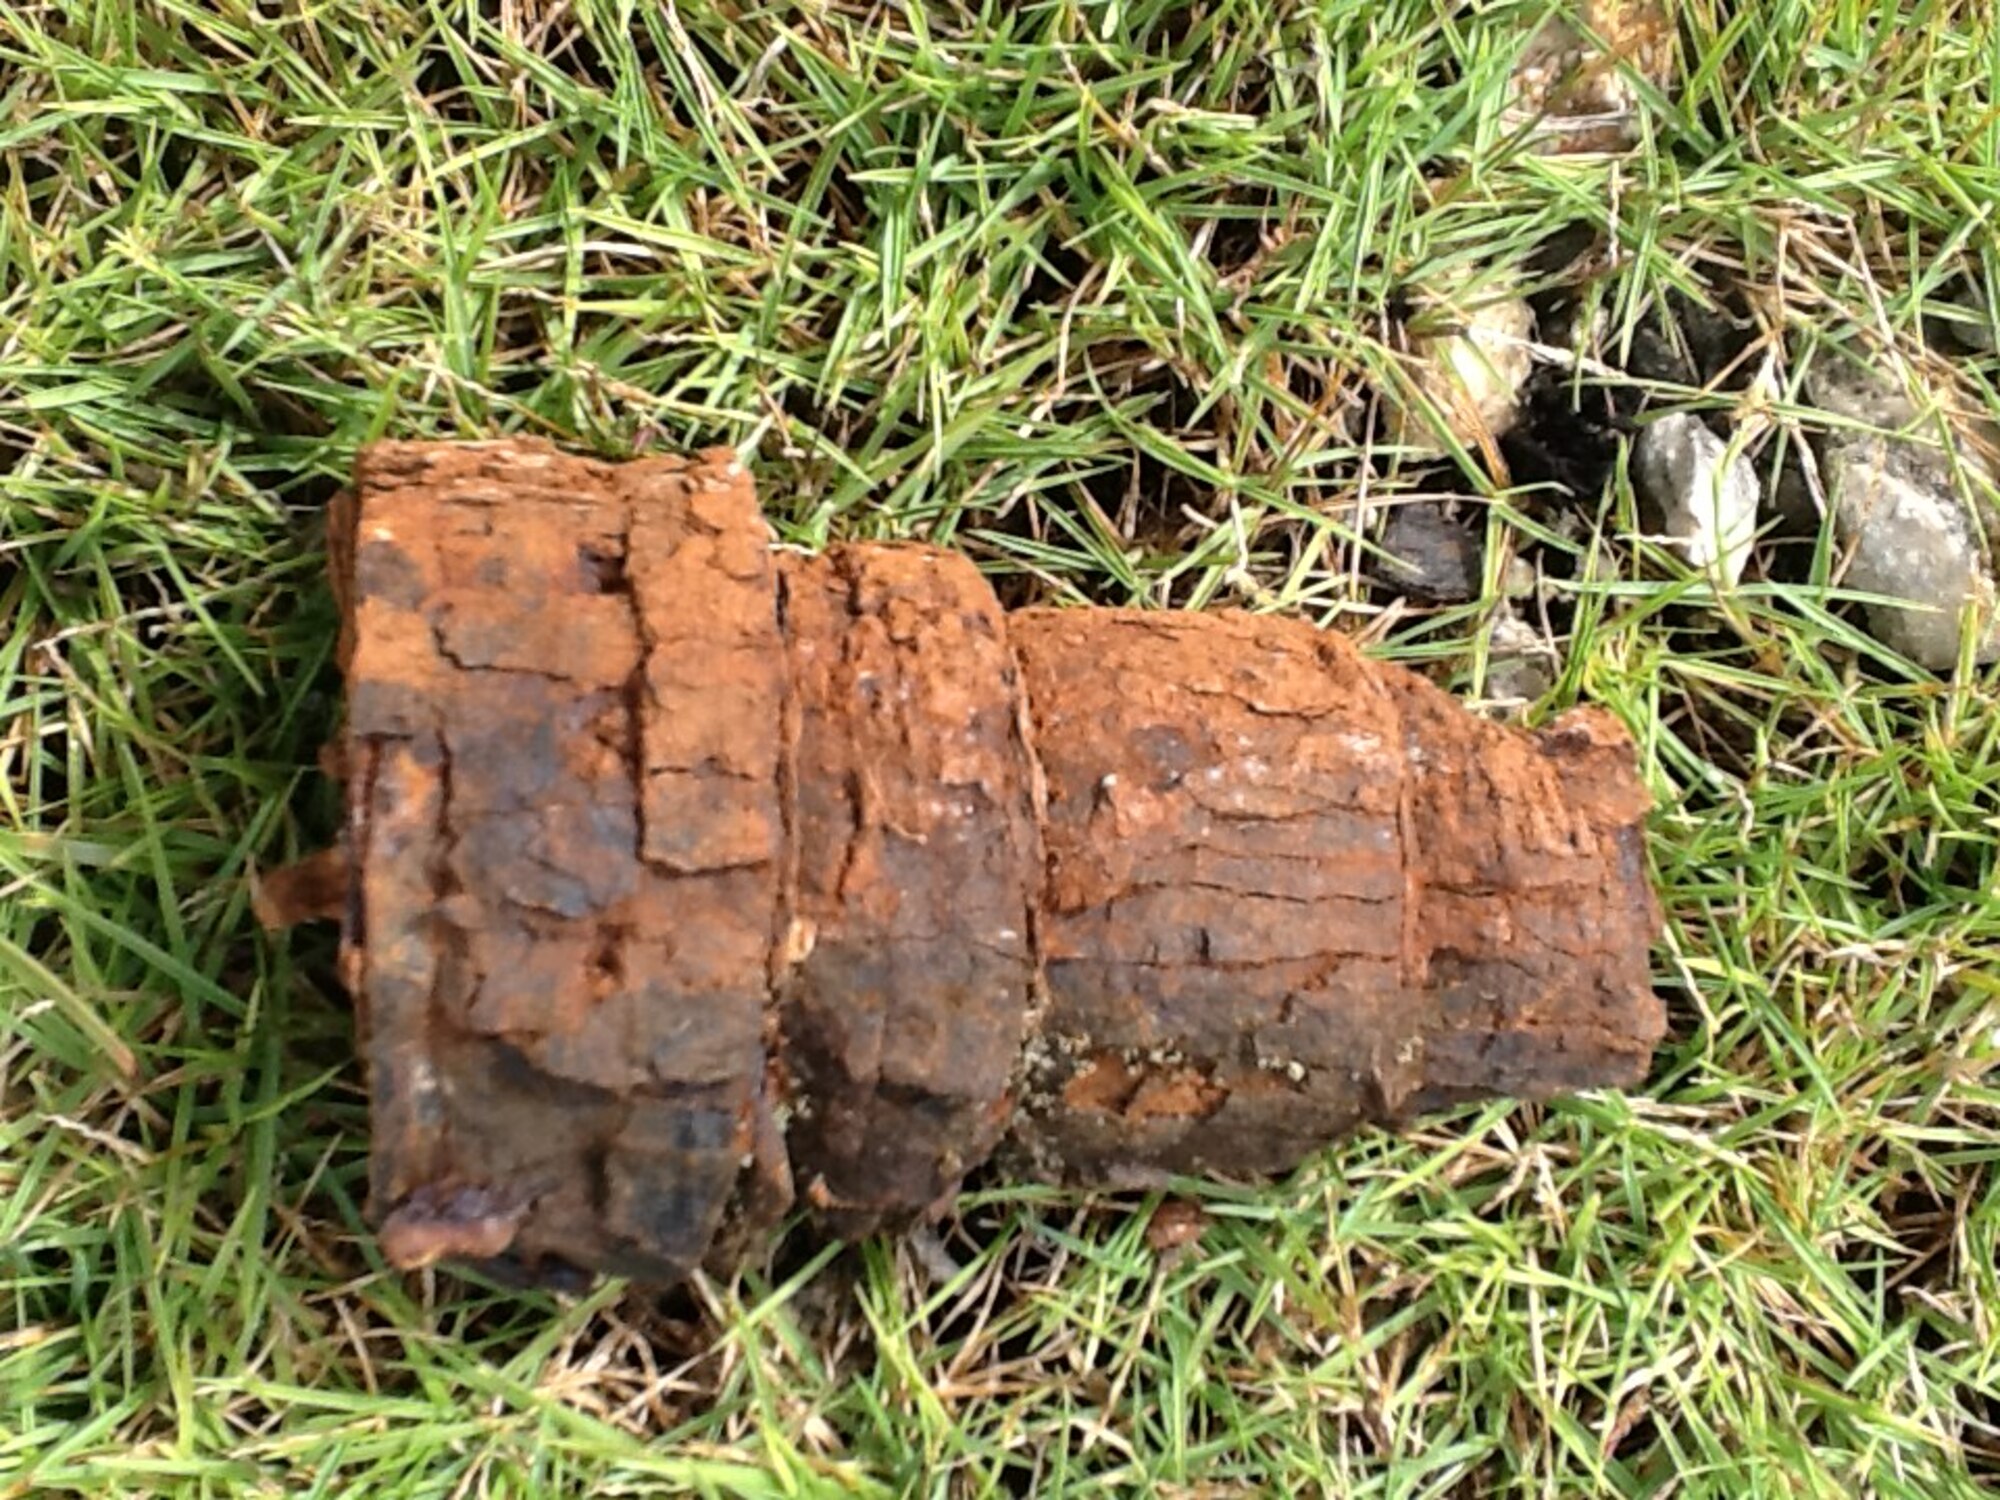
[304, 442, 1662, 1282]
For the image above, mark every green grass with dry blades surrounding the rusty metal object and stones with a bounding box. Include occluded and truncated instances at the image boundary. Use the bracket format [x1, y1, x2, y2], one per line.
[0, 0, 2000, 1500]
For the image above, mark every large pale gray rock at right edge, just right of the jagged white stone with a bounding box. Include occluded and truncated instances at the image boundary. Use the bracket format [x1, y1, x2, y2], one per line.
[1822, 436, 2000, 668]
